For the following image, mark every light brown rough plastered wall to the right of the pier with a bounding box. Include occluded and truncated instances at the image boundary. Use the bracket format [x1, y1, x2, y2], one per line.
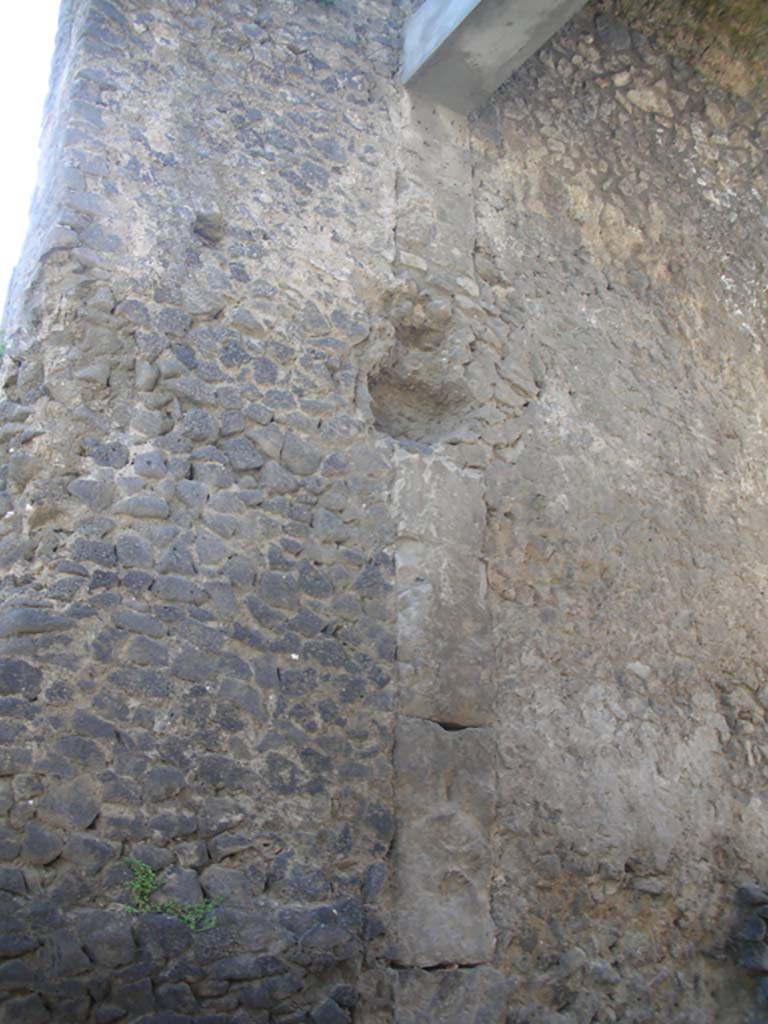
[475, 17, 768, 1021]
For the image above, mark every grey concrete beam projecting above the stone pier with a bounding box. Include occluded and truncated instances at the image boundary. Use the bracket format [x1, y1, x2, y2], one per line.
[402, 0, 585, 114]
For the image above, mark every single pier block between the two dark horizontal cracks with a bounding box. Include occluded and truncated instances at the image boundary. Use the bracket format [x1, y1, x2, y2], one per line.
[395, 719, 496, 967]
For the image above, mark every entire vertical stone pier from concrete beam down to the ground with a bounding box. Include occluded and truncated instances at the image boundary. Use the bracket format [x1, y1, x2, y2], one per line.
[393, 90, 514, 1024]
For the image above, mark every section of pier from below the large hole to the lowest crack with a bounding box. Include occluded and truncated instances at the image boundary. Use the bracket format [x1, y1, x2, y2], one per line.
[395, 456, 496, 967]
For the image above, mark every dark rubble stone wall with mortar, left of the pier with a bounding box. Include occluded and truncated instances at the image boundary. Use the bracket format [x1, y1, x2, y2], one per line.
[0, 0, 399, 1024]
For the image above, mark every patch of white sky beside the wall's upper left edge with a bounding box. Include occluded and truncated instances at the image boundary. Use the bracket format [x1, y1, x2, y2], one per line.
[0, 0, 59, 311]
